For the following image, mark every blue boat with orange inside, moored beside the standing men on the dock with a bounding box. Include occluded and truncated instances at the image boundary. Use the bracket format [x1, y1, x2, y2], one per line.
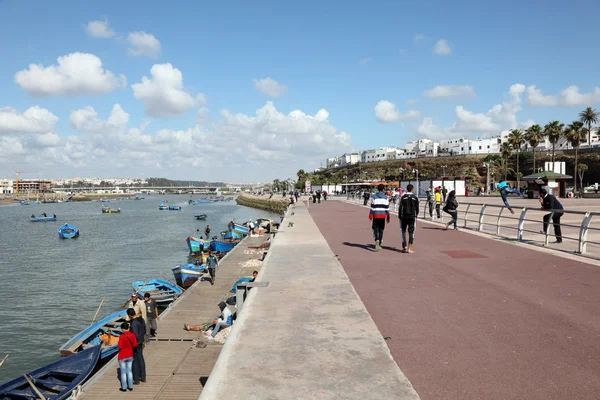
[58, 310, 127, 360]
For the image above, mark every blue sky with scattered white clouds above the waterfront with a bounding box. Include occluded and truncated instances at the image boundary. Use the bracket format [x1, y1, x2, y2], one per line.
[0, 0, 600, 182]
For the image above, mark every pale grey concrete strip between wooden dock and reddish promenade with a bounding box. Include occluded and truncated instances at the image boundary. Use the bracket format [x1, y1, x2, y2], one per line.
[200, 204, 419, 400]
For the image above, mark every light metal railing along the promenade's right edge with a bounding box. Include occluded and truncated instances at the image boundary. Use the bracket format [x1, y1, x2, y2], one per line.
[344, 196, 600, 259]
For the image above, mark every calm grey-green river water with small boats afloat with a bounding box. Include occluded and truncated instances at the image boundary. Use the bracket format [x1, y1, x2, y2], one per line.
[0, 195, 276, 383]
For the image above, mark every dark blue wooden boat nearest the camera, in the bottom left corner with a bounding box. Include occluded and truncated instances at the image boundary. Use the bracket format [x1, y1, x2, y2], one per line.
[0, 346, 100, 400]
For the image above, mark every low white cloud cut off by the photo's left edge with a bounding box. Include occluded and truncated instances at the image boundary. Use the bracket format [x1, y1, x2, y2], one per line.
[0, 106, 58, 134]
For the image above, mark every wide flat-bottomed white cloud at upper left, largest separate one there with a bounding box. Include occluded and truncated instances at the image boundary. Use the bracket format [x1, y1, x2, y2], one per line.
[15, 53, 127, 97]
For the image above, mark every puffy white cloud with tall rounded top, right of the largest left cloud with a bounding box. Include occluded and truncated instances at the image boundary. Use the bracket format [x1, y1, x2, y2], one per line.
[131, 64, 197, 117]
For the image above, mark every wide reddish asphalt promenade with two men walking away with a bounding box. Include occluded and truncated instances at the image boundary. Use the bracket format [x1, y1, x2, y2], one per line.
[310, 201, 600, 400]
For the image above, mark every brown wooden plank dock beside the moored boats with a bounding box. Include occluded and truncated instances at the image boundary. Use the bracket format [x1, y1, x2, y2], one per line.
[77, 235, 268, 400]
